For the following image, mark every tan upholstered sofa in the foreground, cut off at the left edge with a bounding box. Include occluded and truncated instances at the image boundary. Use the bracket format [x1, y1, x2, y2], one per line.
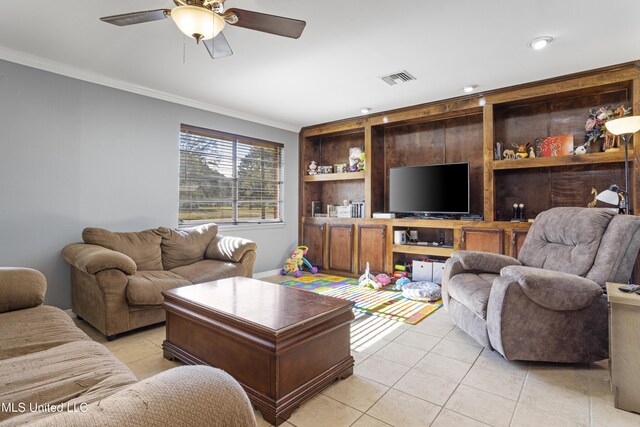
[0, 268, 256, 427]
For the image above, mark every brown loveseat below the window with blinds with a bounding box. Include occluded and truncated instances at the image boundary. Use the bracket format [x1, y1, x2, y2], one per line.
[62, 224, 256, 339]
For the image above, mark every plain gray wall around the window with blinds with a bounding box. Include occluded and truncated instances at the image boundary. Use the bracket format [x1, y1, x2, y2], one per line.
[0, 60, 298, 309]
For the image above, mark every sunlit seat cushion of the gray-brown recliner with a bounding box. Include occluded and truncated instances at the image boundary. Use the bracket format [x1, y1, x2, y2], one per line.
[447, 273, 498, 319]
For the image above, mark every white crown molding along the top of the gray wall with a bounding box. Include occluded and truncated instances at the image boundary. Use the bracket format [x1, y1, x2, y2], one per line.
[0, 46, 300, 133]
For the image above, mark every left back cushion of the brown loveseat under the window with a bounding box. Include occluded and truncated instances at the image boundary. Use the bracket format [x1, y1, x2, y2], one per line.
[82, 227, 162, 270]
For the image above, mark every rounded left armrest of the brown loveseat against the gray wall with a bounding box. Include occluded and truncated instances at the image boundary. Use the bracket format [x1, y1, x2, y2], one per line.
[62, 243, 137, 275]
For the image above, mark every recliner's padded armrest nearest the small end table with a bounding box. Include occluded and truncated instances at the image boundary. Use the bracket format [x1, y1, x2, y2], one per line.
[500, 266, 603, 311]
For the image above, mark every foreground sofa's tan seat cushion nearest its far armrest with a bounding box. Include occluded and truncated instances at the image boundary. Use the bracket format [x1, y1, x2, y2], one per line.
[0, 305, 90, 360]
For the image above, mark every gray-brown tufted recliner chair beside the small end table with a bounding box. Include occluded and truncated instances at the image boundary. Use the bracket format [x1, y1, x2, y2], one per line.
[442, 208, 640, 363]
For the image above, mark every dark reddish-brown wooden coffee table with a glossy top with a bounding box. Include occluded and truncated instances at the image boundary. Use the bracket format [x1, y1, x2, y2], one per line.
[162, 277, 354, 425]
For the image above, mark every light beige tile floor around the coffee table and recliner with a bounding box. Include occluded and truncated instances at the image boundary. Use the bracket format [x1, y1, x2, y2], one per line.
[76, 278, 640, 427]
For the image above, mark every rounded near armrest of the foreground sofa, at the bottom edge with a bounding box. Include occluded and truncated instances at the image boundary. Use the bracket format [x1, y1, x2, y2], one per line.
[32, 366, 257, 427]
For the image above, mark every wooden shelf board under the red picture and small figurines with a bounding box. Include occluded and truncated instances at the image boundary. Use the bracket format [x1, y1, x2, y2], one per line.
[492, 150, 633, 170]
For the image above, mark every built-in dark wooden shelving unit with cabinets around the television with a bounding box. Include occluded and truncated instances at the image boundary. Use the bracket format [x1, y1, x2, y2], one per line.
[299, 62, 640, 275]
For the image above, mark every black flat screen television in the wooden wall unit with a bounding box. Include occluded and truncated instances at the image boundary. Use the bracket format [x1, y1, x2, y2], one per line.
[389, 163, 470, 215]
